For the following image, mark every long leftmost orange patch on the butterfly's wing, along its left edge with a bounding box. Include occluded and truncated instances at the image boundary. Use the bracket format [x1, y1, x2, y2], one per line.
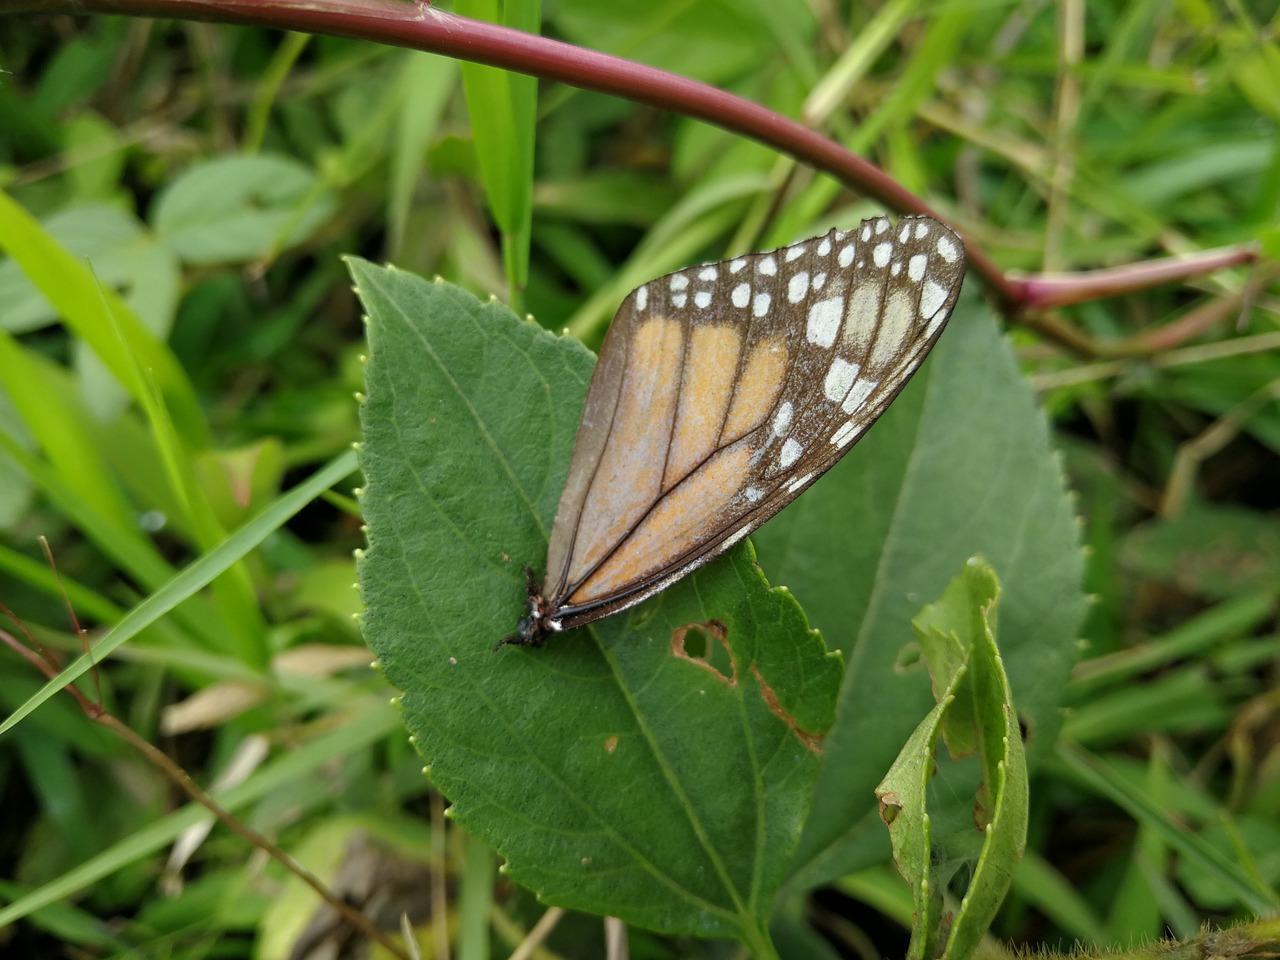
[568, 316, 685, 582]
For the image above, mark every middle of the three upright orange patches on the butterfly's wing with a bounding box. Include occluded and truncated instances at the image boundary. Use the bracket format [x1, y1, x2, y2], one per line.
[662, 325, 742, 490]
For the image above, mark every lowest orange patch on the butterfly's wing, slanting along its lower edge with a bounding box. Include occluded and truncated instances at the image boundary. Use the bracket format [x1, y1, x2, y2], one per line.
[567, 443, 751, 605]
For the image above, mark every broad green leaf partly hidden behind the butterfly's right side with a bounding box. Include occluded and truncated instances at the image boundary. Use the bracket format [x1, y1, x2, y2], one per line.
[754, 291, 1085, 886]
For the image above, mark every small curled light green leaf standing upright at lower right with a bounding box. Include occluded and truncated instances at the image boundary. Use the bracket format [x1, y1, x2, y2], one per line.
[876, 558, 1028, 960]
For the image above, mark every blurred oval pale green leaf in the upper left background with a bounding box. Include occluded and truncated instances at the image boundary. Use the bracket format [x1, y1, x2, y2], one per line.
[152, 155, 337, 265]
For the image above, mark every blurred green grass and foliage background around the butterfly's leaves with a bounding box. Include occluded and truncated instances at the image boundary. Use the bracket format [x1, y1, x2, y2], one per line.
[0, 7, 1280, 957]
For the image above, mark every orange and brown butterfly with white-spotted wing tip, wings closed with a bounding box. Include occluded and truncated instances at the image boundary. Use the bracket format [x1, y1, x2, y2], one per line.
[498, 209, 965, 646]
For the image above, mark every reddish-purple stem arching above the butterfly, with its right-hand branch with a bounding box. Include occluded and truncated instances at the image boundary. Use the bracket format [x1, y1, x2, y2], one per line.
[0, 0, 1256, 335]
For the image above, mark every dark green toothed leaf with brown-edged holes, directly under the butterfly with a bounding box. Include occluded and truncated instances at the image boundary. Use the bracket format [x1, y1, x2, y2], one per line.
[352, 260, 840, 954]
